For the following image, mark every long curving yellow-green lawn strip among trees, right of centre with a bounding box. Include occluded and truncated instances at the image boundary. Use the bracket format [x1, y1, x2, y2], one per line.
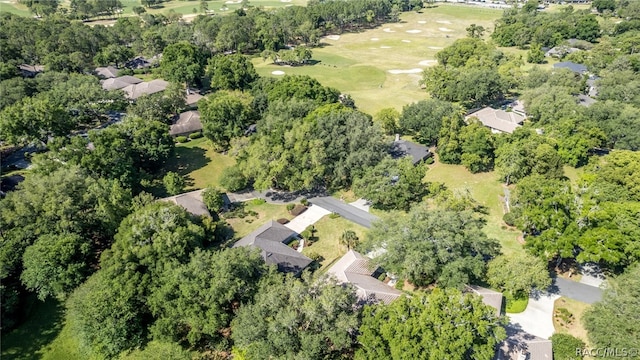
[425, 161, 522, 255]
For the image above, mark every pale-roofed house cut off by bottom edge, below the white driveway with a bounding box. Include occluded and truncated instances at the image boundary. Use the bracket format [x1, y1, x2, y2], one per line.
[493, 326, 553, 360]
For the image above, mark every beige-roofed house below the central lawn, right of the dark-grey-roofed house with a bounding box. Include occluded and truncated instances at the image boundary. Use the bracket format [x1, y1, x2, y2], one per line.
[327, 250, 402, 304]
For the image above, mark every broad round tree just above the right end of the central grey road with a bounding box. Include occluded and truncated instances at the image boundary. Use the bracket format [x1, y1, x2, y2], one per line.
[352, 158, 428, 210]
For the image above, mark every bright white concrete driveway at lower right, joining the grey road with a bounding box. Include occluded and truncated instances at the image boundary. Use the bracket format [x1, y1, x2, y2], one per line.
[507, 293, 560, 339]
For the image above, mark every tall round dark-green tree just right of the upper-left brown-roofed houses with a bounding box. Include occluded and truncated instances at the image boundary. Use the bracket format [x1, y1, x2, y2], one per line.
[160, 42, 204, 89]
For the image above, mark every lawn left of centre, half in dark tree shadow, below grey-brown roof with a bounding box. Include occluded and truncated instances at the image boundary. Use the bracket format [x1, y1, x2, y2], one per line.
[165, 138, 235, 190]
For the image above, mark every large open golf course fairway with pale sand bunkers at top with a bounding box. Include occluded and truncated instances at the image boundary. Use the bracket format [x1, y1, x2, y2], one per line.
[253, 4, 502, 114]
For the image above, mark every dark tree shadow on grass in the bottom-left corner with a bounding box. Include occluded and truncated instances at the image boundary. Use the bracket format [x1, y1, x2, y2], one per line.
[2, 297, 64, 360]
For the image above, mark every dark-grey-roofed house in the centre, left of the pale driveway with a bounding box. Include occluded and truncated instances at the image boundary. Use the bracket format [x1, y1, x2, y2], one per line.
[233, 220, 313, 274]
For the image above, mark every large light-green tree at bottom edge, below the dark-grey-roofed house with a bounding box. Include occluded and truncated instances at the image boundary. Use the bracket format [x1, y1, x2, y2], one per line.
[231, 272, 359, 359]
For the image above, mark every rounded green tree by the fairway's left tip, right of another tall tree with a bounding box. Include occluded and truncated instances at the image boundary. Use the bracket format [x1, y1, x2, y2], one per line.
[206, 54, 258, 90]
